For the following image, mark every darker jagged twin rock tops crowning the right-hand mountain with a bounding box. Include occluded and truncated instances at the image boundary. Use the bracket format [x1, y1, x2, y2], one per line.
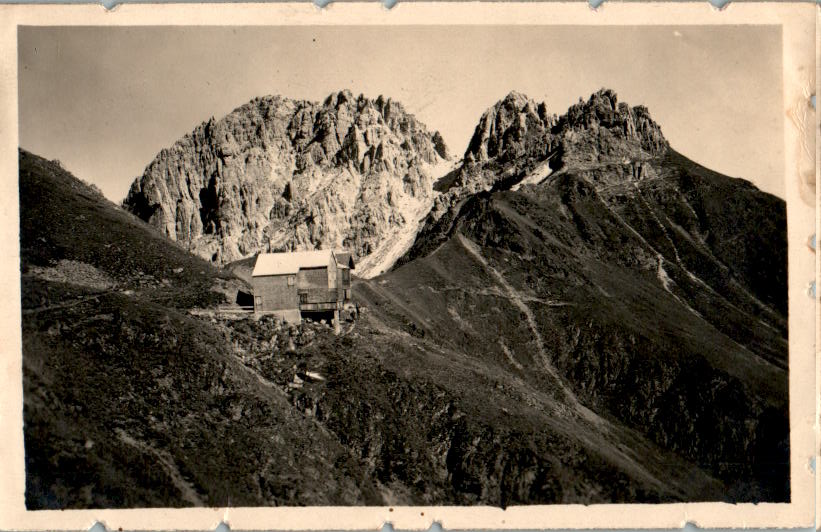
[432, 89, 669, 212]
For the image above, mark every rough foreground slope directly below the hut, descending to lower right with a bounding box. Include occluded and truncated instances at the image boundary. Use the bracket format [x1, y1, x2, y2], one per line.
[224, 306, 722, 506]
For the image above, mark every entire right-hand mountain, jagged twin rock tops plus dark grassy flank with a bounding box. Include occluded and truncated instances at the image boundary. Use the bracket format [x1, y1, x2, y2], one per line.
[384, 91, 789, 500]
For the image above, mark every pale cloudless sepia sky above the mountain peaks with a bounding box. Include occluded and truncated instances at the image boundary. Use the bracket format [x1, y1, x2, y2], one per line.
[19, 26, 785, 202]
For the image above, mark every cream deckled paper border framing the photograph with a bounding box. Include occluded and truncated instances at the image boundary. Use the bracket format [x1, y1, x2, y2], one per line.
[0, 3, 817, 530]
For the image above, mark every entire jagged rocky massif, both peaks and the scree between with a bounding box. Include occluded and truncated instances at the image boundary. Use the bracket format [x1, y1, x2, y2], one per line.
[123, 89, 669, 277]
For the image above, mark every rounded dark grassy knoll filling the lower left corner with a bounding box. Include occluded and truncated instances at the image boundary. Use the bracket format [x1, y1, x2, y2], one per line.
[23, 295, 376, 507]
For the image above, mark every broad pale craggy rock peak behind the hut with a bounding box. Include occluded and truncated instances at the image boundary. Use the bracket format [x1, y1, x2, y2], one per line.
[123, 91, 447, 273]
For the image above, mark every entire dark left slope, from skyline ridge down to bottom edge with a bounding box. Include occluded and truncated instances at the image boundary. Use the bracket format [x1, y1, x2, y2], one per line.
[20, 152, 380, 508]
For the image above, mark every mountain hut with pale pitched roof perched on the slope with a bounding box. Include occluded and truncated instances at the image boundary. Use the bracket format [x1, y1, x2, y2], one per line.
[251, 249, 355, 323]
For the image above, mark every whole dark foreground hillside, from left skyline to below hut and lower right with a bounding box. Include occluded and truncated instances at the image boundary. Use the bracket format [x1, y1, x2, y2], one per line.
[20, 152, 722, 508]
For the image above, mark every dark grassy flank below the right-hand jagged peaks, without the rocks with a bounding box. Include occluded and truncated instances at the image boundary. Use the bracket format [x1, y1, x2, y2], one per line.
[378, 154, 789, 500]
